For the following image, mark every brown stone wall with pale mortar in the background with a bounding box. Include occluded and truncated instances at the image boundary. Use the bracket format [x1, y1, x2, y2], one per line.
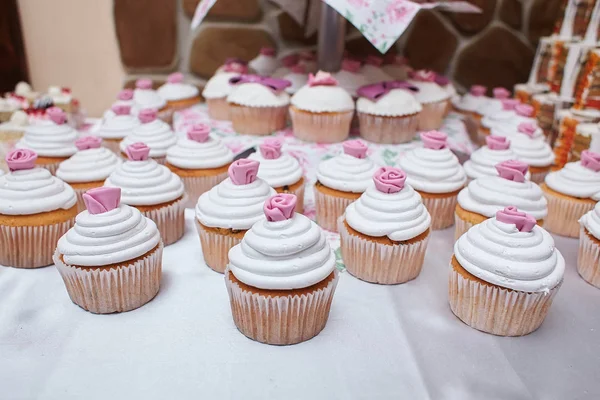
[114, 0, 564, 94]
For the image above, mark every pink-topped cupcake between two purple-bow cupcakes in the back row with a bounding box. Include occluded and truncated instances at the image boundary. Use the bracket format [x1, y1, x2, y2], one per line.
[290, 71, 354, 143]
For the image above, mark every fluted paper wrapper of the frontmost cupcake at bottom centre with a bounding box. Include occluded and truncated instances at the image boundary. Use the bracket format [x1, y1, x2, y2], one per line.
[225, 271, 339, 345]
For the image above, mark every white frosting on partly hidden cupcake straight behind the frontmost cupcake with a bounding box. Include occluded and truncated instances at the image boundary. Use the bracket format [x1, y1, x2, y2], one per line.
[248, 151, 302, 188]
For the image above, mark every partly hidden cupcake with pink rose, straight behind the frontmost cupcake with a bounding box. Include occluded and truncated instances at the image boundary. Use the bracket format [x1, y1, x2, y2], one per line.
[248, 138, 305, 214]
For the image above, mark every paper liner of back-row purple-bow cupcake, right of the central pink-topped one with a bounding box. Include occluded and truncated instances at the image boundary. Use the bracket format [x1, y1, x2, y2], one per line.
[358, 112, 419, 144]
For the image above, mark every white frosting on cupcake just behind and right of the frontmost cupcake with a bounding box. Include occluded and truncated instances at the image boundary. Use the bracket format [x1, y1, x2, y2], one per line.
[346, 185, 431, 242]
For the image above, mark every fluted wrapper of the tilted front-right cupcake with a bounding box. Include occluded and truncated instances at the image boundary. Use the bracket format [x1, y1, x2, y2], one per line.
[448, 255, 562, 336]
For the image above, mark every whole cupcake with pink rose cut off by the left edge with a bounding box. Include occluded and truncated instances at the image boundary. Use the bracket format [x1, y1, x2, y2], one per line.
[0, 149, 77, 268]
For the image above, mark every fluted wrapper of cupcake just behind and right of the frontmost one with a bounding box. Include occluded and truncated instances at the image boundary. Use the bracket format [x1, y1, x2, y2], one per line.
[338, 217, 429, 285]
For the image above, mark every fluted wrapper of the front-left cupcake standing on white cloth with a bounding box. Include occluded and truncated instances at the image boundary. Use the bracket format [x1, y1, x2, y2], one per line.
[54, 243, 163, 314]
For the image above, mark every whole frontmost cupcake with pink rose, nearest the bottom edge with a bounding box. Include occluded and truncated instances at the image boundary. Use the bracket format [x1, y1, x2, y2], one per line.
[225, 194, 338, 345]
